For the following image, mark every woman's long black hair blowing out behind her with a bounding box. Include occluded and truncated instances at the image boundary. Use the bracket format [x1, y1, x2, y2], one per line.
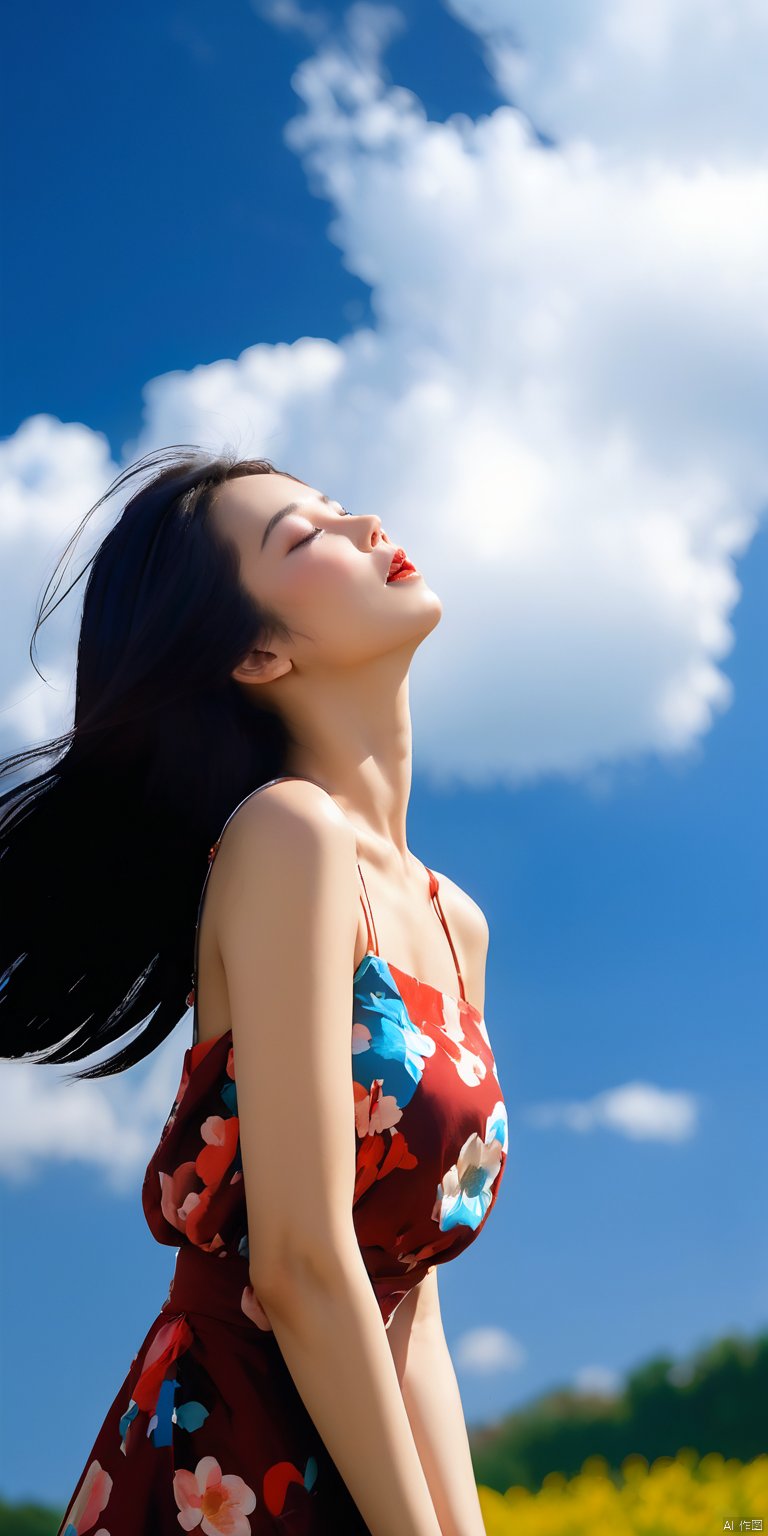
[0, 444, 308, 1080]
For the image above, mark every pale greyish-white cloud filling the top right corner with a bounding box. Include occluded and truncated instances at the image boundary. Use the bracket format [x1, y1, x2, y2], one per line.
[445, 0, 768, 167]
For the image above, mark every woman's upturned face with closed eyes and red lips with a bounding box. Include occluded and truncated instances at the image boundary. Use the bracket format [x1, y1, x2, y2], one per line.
[214, 473, 442, 670]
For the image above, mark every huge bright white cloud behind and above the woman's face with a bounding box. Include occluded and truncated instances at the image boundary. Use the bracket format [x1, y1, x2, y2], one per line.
[5, 0, 768, 785]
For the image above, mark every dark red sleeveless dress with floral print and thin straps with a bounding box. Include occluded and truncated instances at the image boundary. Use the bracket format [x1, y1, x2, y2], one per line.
[57, 774, 507, 1536]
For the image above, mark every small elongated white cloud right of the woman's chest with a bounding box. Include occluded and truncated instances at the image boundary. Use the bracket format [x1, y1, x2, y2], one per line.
[522, 1083, 700, 1143]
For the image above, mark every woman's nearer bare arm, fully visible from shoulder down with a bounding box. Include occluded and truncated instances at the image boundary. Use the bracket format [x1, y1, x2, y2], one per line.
[210, 782, 441, 1536]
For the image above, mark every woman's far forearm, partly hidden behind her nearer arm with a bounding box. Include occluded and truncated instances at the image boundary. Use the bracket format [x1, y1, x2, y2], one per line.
[389, 1267, 485, 1536]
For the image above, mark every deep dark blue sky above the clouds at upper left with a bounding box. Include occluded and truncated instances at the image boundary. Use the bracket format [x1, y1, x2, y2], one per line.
[0, 0, 488, 452]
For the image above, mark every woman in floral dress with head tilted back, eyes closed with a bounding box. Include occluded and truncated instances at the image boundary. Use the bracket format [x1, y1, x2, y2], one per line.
[0, 447, 507, 1536]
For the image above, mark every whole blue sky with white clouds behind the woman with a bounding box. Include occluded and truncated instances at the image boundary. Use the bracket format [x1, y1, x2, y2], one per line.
[0, 0, 768, 1501]
